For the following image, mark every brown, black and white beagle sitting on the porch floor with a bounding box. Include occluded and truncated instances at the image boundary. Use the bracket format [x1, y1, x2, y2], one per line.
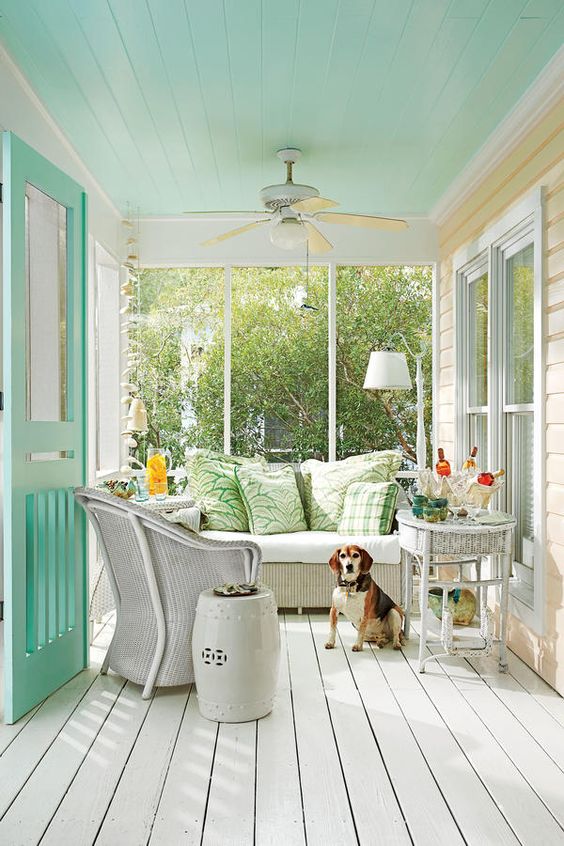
[325, 544, 404, 652]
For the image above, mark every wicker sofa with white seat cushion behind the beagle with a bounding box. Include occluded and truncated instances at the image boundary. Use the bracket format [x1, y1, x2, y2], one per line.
[196, 464, 403, 613]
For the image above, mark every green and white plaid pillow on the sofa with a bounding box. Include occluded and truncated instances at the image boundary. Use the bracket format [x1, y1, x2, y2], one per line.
[339, 482, 398, 535]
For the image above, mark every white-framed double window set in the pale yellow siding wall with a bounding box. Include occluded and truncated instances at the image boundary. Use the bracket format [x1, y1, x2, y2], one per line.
[454, 191, 545, 632]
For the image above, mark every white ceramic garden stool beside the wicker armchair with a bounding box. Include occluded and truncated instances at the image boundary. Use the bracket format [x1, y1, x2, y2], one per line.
[192, 588, 280, 723]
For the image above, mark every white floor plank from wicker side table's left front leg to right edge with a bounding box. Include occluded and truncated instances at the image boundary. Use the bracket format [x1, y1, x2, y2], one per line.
[420, 644, 564, 826]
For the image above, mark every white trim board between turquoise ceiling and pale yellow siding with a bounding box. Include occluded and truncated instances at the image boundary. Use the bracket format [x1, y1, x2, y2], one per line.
[429, 46, 564, 226]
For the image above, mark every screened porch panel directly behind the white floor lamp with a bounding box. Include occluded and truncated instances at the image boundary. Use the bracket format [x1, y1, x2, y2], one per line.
[336, 265, 433, 460]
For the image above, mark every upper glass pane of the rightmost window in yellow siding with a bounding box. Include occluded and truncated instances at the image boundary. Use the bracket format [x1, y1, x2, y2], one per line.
[505, 244, 534, 405]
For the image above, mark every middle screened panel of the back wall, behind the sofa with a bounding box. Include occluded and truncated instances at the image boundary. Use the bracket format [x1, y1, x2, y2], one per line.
[231, 267, 329, 462]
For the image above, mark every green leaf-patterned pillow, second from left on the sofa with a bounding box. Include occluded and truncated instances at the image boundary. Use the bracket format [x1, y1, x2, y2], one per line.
[235, 465, 307, 535]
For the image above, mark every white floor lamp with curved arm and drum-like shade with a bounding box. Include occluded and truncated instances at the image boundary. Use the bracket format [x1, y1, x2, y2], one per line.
[363, 332, 427, 470]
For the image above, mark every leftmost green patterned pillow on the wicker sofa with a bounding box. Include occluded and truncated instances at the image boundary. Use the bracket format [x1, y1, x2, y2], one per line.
[187, 452, 261, 532]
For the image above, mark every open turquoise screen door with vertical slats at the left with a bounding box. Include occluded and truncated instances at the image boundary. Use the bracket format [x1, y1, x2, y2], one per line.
[2, 132, 88, 723]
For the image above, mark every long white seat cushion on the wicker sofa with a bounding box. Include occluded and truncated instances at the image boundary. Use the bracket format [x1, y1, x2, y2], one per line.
[201, 531, 400, 564]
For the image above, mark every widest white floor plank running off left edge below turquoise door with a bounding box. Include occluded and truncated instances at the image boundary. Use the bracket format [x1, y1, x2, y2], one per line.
[0, 669, 98, 818]
